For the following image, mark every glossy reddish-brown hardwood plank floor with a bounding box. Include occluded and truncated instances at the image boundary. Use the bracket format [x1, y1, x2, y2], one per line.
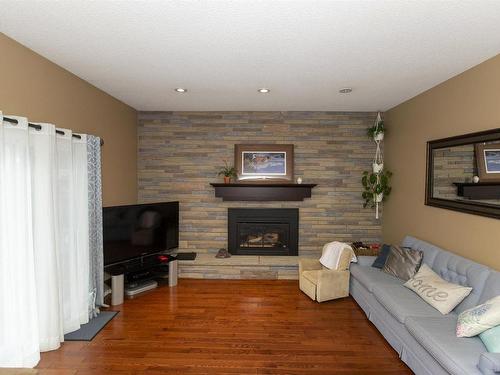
[38, 279, 411, 375]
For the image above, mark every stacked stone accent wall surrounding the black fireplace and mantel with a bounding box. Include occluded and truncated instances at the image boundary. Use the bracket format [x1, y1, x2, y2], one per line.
[141, 111, 381, 279]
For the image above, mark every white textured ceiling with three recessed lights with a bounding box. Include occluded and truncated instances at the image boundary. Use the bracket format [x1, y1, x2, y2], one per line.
[0, 0, 500, 111]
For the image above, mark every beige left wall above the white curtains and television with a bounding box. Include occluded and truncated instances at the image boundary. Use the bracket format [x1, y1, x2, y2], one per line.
[0, 33, 137, 206]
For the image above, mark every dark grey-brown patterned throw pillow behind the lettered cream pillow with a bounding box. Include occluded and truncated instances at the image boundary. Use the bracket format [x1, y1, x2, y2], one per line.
[382, 246, 424, 281]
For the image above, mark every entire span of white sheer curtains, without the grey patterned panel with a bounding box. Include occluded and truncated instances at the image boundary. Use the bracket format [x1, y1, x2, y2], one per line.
[0, 112, 97, 368]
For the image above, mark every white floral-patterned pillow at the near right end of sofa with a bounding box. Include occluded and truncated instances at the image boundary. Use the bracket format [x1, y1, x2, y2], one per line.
[457, 296, 500, 337]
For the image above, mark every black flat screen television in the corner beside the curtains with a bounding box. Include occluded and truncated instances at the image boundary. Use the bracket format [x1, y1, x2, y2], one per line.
[103, 202, 179, 266]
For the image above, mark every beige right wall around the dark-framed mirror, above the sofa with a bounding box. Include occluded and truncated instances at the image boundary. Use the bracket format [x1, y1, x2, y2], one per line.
[383, 55, 500, 270]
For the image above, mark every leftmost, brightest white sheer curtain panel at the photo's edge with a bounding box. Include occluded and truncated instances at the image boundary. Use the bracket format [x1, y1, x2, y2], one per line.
[0, 113, 40, 367]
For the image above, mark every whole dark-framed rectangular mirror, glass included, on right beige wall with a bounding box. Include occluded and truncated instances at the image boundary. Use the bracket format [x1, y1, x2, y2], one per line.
[425, 128, 500, 219]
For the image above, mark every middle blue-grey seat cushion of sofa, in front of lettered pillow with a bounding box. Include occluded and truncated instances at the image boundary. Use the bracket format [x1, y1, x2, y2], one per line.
[373, 284, 446, 324]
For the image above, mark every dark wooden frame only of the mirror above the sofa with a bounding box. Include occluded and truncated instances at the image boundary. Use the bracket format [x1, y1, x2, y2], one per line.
[425, 128, 500, 219]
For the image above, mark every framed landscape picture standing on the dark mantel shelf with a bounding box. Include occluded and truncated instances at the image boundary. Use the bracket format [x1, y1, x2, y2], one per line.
[234, 144, 293, 183]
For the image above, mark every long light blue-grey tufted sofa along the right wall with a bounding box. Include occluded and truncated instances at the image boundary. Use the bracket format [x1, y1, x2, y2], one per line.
[350, 237, 500, 375]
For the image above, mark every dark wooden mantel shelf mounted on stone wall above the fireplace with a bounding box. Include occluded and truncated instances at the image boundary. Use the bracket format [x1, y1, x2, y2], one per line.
[210, 183, 316, 201]
